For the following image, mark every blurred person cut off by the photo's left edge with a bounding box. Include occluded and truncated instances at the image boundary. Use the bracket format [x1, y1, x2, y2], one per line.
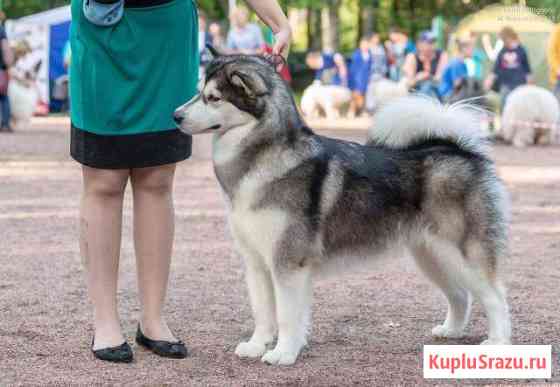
[0, 11, 14, 132]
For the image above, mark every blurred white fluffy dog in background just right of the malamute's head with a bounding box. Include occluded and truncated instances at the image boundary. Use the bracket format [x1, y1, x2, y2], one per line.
[301, 81, 352, 119]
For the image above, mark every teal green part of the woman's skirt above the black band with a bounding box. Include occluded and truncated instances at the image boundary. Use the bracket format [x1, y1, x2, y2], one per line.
[70, 0, 199, 135]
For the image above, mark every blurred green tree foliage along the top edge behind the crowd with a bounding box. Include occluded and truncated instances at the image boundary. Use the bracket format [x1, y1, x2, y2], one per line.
[0, 0, 560, 50]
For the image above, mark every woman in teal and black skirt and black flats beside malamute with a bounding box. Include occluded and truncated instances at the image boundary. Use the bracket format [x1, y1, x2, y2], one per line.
[70, 0, 291, 362]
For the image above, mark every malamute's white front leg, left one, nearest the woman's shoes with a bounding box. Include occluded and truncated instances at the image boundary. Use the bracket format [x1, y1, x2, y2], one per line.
[235, 254, 276, 357]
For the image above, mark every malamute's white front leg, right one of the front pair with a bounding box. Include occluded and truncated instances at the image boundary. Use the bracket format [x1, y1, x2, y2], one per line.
[261, 266, 312, 365]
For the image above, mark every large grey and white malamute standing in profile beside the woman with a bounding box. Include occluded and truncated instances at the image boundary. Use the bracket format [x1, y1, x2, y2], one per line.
[175, 56, 510, 365]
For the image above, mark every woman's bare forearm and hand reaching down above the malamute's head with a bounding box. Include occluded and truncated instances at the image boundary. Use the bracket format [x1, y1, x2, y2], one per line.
[246, 0, 292, 58]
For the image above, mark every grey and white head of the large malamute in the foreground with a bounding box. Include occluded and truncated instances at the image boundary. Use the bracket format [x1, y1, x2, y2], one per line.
[174, 52, 287, 134]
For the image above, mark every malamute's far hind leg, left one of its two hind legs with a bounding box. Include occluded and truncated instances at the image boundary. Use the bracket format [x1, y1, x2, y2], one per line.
[412, 240, 472, 338]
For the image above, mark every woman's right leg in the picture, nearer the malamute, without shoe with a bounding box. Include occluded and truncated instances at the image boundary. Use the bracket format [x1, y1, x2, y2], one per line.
[130, 164, 176, 341]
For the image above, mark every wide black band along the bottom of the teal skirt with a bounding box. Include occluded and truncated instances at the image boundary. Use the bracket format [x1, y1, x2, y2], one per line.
[70, 125, 192, 169]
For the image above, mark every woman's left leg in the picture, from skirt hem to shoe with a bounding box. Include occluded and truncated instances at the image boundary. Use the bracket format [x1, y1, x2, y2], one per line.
[80, 166, 129, 350]
